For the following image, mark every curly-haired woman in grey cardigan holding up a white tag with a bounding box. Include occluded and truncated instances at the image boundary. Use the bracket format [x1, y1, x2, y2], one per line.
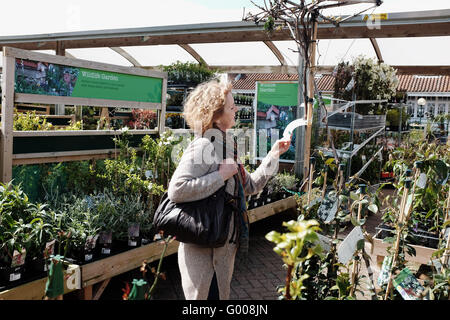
[168, 80, 290, 300]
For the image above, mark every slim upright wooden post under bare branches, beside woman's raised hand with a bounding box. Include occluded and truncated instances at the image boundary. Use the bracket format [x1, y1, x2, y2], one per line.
[303, 20, 318, 177]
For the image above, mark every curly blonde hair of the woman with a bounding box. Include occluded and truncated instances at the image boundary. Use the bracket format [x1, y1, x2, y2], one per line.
[183, 80, 232, 134]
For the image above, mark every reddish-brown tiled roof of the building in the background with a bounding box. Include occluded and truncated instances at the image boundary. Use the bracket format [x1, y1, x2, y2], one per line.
[228, 73, 450, 93]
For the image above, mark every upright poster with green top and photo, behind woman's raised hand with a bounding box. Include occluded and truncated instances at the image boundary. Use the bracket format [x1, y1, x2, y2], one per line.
[254, 81, 298, 163]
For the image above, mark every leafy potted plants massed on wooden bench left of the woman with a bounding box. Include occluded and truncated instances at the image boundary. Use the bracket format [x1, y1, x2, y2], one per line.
[0, 131, 183, 296]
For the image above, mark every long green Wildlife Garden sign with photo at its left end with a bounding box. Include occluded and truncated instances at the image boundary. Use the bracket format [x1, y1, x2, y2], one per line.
[15, 59, 163, 103]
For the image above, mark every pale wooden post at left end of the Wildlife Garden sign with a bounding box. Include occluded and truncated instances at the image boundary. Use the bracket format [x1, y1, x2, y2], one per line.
[0, 47, 16, 183]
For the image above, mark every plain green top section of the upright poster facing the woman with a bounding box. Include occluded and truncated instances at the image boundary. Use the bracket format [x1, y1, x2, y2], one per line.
[257, 82, 298, 106]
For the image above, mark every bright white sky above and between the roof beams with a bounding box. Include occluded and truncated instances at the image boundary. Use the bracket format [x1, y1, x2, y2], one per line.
[0, 0, 450, 65]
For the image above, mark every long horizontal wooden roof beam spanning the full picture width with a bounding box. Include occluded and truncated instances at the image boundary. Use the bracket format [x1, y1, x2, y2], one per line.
[0, 10, 450, 50]
